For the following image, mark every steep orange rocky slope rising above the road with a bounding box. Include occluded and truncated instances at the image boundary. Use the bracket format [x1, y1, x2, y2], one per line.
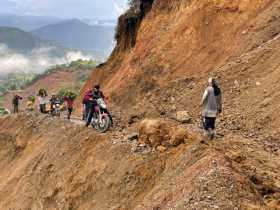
[81, 0, 280, 130]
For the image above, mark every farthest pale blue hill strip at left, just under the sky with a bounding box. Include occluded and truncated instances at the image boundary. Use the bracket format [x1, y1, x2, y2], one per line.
[0, 15, 61, 31]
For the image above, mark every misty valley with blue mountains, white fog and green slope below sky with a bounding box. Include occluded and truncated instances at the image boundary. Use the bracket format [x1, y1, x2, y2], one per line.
[0, 15, 116, 106]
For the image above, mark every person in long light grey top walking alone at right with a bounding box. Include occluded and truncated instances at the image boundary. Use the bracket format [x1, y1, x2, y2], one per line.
[201, 78, 222, 139]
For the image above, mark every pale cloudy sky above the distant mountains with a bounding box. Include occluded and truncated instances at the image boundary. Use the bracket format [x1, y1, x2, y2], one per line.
[0, 0, 127, 19]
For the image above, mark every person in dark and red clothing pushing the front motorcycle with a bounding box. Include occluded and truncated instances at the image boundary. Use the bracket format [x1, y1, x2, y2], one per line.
[86, 85, 113, 127]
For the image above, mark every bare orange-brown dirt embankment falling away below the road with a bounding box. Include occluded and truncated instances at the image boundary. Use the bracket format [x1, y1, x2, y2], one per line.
[0, 114, 280, 210]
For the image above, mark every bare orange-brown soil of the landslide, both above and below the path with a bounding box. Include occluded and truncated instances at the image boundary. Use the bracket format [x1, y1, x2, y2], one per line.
[0, 0, 280, 210]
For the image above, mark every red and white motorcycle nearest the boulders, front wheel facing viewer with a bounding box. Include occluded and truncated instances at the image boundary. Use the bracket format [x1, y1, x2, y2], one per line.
[91, 98, 112, 133]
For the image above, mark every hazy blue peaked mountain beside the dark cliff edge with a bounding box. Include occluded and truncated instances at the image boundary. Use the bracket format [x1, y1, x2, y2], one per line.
[32, 19, 114, 53]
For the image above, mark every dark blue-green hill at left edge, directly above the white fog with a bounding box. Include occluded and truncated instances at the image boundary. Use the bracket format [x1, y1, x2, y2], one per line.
[0, 27, 61, 52]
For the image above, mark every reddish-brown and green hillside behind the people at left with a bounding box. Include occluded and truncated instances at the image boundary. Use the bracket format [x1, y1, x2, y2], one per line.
[0, 60, 94, 109]
